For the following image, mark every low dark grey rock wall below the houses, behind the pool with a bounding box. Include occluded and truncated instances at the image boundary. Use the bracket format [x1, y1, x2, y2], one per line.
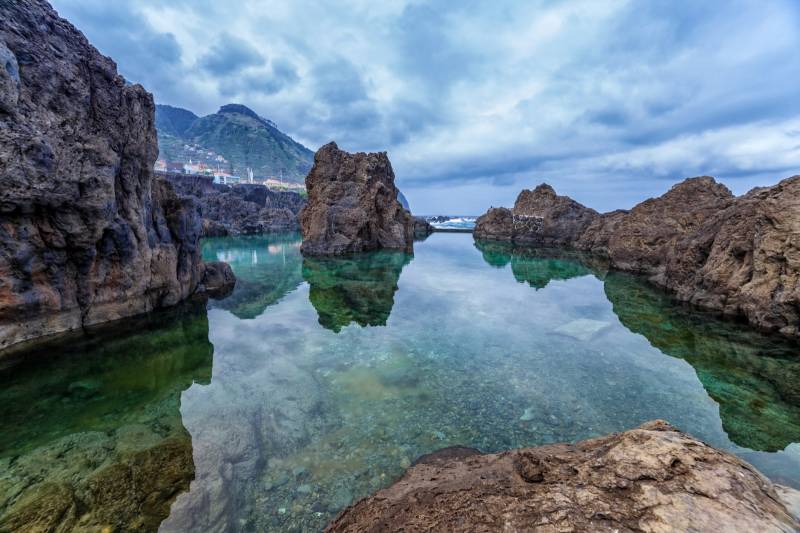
[166, 174, 306, 237]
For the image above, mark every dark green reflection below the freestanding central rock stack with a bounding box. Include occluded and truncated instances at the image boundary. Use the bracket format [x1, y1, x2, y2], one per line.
[303, 250, 413, 333]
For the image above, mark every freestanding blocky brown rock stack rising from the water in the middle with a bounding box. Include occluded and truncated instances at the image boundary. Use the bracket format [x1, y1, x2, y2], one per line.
[300, 143, 414, 255]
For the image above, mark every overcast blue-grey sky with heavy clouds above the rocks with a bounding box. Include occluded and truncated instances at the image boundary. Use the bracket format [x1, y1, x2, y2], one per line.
[51, 0, 800, 214]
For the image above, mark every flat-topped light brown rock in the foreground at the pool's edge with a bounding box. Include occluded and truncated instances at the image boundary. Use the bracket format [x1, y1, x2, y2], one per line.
[327, 421, 800, 532]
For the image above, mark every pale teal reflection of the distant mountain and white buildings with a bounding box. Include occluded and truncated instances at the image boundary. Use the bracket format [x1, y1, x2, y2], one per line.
[203, 233, 303, 319]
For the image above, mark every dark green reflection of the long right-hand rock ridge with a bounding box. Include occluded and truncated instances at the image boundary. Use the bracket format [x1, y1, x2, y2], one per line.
[475, 241, 800, 451]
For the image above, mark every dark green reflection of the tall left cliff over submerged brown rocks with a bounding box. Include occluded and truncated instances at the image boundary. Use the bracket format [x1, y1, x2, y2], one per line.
[0, 302, 213, 531]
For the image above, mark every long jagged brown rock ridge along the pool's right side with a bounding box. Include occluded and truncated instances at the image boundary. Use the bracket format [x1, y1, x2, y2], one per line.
[475, 176, 800, 337]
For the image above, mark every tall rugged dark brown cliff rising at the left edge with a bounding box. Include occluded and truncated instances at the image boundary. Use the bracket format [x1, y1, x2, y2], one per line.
[0, 0, 231, 349]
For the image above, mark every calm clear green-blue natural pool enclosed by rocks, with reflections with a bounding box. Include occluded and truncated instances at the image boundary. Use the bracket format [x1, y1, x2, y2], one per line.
[0, 234, 800, 531]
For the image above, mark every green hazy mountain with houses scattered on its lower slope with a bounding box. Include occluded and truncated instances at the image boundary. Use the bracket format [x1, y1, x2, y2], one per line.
[156, 104, 314, 183]
